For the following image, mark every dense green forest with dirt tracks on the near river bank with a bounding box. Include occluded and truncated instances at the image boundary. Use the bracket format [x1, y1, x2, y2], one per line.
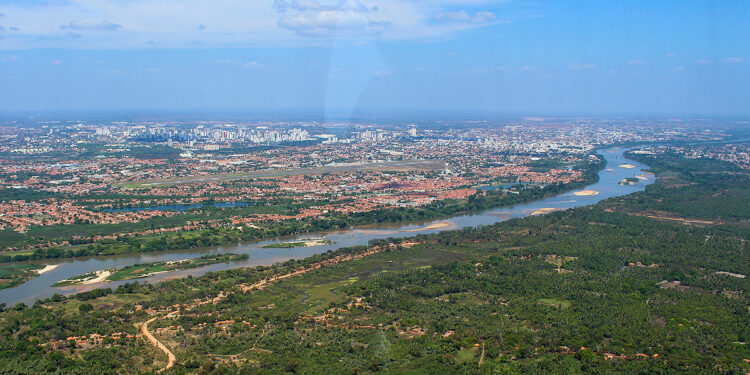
[0, 151, 750, 374]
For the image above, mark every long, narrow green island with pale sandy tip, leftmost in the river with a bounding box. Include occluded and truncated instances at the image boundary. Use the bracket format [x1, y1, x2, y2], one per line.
[52, 254, 249, 286]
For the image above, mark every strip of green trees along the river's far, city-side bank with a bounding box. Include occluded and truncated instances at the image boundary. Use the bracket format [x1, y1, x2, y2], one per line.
[0, 158, 605, 262]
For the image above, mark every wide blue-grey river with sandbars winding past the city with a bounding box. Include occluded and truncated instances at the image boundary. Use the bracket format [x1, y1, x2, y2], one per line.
[0, 148, 654, 306]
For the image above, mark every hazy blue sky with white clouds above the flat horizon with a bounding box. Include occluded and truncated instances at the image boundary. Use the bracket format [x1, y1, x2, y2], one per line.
[0, 0, 750, 117]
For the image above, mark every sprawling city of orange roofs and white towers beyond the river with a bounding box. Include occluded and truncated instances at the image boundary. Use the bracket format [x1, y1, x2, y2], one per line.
[0, 118, 749, 239]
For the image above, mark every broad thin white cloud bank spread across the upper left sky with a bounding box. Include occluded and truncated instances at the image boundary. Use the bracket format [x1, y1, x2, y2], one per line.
[0, 0, 507, 50]
